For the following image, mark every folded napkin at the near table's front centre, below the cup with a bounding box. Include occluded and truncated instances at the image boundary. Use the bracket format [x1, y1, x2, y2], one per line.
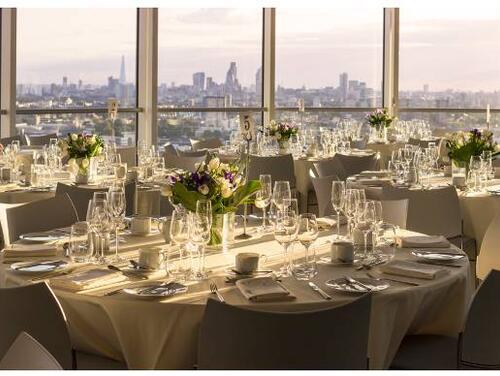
[236, 277, 295, 302]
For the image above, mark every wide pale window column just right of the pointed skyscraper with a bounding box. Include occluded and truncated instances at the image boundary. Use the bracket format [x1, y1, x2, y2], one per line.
[137, 8, 158, 145]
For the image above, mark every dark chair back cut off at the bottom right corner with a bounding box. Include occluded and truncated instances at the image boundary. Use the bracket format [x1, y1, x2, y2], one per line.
[460, 269, 500, 369]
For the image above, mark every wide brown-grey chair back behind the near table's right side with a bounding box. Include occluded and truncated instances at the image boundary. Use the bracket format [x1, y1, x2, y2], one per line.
[382, 186, 462, 238]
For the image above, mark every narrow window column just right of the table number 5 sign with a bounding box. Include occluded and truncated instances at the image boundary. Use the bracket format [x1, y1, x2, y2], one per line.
[262, 8, 276, 124]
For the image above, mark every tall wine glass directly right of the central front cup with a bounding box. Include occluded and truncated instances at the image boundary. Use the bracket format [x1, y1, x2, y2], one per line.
[274, 198, 299, 277]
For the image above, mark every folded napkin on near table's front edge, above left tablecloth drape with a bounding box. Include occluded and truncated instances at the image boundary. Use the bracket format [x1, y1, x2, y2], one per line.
[50, 269, 127, 292]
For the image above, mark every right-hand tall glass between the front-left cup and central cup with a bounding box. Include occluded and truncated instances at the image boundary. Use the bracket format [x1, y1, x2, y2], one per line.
[189, 200, 212, 280]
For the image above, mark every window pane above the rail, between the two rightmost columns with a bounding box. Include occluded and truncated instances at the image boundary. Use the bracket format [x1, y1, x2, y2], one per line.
[275, 7, 383, 108]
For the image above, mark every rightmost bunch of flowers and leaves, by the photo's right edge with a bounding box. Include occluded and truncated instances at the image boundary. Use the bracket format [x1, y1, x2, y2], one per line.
[446, 129, 498, 167]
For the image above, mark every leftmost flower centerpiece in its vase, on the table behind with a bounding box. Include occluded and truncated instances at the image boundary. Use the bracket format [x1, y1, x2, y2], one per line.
[59, 133, 104, 184]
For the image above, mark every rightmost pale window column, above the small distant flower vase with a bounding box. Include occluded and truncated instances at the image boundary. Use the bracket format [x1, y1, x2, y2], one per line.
[383, 8, 399, 116]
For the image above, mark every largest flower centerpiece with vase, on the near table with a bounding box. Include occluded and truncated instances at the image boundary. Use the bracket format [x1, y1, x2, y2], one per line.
[162, 154, 260, 246]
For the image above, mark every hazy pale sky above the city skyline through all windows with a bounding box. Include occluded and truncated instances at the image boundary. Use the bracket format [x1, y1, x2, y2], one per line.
[17, 6, 500, 91]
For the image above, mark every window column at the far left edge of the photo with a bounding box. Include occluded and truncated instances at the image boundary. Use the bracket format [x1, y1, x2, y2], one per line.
[0, 8, 17, 137]
